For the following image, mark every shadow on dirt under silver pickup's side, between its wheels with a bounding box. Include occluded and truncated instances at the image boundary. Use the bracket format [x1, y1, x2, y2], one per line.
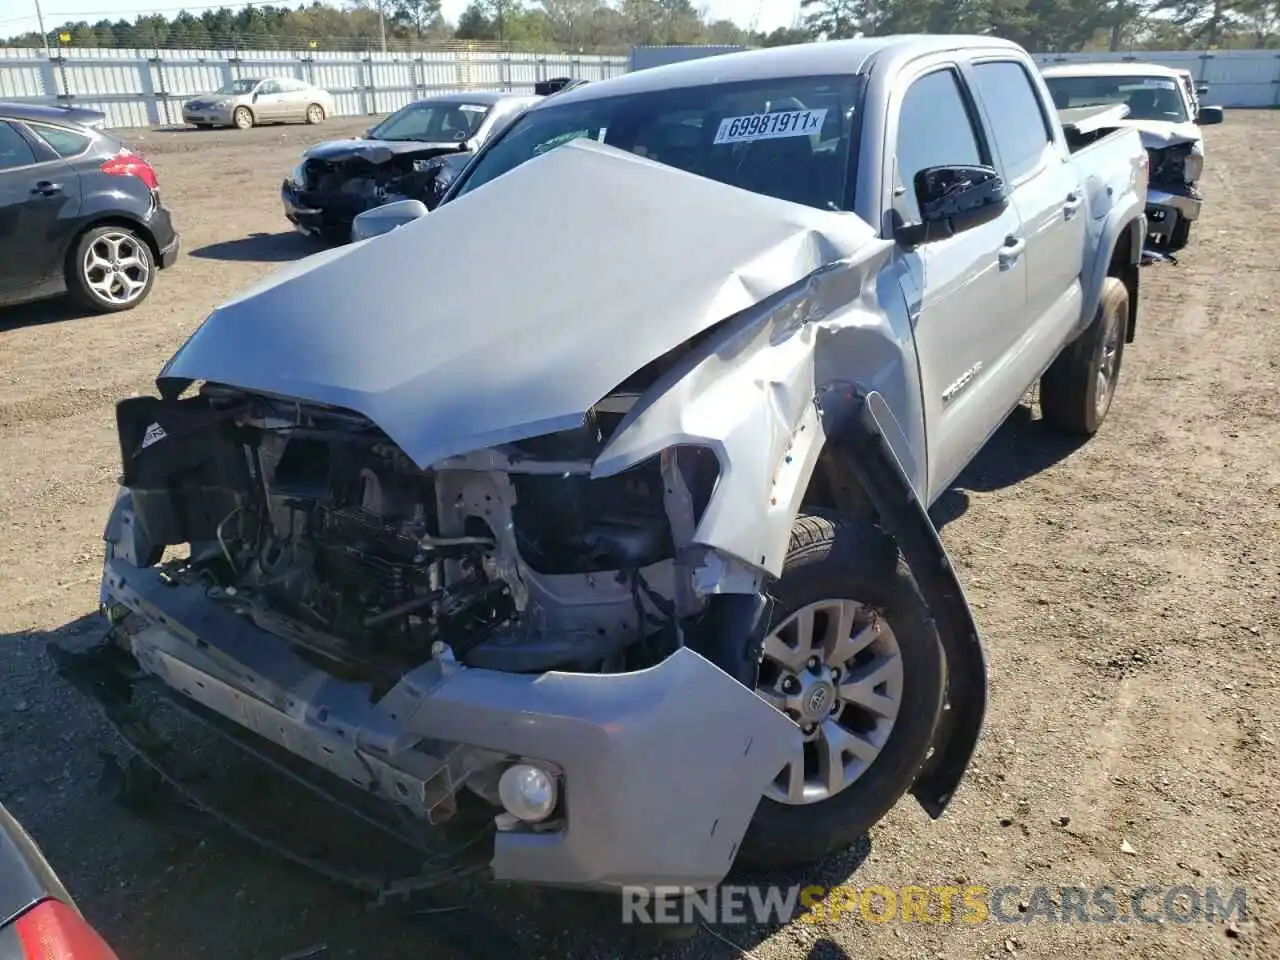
[929, 404, 1087, 530]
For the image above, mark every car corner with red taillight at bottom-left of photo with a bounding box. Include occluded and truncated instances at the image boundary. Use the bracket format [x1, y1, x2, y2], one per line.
[0, 804, 119, 960]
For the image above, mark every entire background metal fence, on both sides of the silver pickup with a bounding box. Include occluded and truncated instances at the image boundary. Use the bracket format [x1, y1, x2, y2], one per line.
[0, 47, 1280, 127]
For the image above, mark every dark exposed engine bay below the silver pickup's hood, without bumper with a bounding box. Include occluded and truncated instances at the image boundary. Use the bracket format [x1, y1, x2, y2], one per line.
[118, 385, 717, 678]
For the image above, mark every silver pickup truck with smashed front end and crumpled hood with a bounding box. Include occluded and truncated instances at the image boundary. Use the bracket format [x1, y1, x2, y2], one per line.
[64, 36, 1147, 891]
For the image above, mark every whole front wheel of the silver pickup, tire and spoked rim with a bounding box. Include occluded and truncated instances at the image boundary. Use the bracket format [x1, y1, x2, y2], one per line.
[741, 516, 946, 867]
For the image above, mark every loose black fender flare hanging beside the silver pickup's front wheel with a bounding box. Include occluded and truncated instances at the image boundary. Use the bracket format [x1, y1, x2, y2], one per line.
[819, 387, 987, 819]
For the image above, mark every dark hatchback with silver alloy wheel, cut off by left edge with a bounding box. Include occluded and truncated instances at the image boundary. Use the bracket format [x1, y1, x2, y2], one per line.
[0, 102, 178, 312]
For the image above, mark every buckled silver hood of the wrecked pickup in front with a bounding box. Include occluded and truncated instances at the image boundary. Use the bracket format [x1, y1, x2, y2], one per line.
[157, 141, 874, 467]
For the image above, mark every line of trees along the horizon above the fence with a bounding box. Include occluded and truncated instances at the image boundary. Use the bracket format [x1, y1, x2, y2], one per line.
[3, 0, 1280, 52]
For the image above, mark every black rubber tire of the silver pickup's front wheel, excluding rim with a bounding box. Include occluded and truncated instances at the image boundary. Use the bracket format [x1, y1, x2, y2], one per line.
[739, 515, 946, 868]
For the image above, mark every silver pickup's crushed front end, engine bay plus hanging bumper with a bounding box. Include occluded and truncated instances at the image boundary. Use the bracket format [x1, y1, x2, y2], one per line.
[64, 384, 796, 890]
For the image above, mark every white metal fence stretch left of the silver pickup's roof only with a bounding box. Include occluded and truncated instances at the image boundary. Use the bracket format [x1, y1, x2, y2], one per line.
[0, 47, 627, 127]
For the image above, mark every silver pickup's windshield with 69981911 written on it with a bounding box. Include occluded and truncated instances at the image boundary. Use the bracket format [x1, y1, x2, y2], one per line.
[453, 76, 860, 210]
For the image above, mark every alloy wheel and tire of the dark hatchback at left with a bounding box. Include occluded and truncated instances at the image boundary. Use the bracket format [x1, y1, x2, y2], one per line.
[65, 224, 156, 314]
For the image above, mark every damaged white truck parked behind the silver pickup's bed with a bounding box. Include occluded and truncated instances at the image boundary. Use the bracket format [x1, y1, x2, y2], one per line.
[1044, 63, 1225, 253]
